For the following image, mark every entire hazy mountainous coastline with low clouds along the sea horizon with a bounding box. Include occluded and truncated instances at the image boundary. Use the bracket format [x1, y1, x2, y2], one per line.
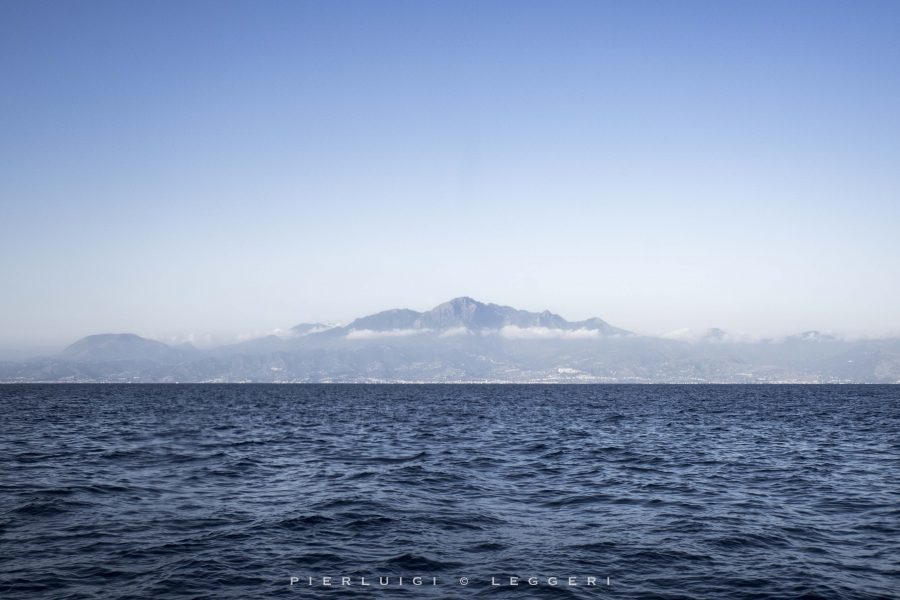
[0, 296, 900, 383]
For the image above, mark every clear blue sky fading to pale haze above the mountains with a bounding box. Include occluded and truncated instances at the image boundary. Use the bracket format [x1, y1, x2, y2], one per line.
[0, 0, 900, 351]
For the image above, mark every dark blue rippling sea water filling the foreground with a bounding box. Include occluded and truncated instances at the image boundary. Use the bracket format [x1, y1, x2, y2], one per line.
[0, 385, 900, 599]
